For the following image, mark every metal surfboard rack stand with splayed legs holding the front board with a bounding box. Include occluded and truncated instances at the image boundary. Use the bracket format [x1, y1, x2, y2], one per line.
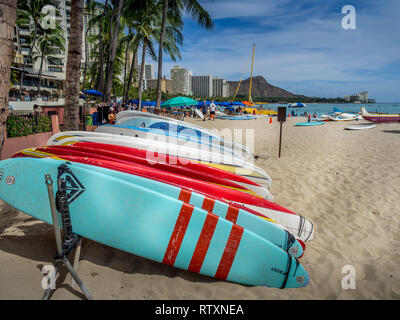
[42, 174, 93, 300]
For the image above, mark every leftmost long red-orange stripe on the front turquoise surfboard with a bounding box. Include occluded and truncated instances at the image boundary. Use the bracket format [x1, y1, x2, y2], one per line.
[162, 203, 194, 266]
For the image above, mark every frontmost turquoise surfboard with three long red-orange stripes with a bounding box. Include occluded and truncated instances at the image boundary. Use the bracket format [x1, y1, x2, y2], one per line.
[0, 158, 309, 288]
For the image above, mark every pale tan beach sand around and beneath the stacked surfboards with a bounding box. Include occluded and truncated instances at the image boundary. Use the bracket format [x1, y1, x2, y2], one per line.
[0, 118, 400, 300]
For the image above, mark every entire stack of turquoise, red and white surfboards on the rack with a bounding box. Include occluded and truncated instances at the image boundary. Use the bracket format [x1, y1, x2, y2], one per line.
[0, 111, 314, 288]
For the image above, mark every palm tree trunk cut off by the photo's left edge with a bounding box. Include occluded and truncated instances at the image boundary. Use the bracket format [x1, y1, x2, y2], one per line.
[0, 0, 17, 154]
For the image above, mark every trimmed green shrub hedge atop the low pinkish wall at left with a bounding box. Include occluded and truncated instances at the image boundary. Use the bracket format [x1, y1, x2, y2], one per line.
[6, 115, 52, 138]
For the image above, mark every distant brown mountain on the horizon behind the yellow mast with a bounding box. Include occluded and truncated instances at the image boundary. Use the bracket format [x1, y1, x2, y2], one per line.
[227, 76, 304, 98]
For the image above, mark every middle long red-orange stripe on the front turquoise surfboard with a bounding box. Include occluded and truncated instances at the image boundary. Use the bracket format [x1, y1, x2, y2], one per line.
[188, 213, 218, 273]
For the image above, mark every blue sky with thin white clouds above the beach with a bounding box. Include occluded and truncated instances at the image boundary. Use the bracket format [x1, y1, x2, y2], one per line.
[157, 0, 400, 102]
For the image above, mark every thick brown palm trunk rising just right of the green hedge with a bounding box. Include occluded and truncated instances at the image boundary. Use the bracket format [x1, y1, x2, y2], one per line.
[64, 0, 84, 130]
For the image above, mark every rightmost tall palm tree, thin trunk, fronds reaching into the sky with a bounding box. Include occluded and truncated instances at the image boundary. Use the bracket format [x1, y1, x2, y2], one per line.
[156, 0, 214, 108]
